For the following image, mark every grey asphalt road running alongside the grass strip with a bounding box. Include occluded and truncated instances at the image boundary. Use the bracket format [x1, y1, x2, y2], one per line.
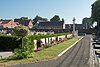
[12, 36, 90, 67]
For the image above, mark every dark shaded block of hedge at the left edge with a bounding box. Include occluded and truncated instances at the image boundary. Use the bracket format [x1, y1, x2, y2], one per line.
[0, 35, 22, 51]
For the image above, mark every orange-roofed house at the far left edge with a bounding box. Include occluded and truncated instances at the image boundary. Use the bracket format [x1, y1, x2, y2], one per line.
[0, 20, 17, 28]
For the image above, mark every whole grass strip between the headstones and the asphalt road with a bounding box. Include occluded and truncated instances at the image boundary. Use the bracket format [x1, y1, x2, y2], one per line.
[0, 38, 80, 67]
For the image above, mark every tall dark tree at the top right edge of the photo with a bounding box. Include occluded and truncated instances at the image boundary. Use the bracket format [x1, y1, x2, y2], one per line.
[91, 0, 100, 29]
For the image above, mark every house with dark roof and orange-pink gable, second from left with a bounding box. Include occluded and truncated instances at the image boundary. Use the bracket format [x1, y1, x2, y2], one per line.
[14, 19, 33, 28]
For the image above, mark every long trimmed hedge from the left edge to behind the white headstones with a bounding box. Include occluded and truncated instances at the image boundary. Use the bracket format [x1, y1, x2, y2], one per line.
[0, 33, 71, 50]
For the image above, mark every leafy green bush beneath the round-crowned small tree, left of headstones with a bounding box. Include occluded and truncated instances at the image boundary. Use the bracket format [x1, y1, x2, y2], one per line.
[14, 37, 33, 59]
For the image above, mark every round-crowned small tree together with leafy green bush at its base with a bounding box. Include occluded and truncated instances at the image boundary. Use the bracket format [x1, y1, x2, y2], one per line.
[14, 25, 33, 59]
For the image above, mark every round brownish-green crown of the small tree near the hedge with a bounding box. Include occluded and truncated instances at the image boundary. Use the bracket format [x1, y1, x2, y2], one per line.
[14, 25, 29, 38]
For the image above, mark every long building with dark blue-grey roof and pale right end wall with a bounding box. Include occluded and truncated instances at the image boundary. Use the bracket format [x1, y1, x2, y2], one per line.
[37, 21, 65, 29]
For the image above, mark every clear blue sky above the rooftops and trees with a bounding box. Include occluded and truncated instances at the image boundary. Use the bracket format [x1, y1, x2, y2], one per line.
[0, 0, 95, 23]
